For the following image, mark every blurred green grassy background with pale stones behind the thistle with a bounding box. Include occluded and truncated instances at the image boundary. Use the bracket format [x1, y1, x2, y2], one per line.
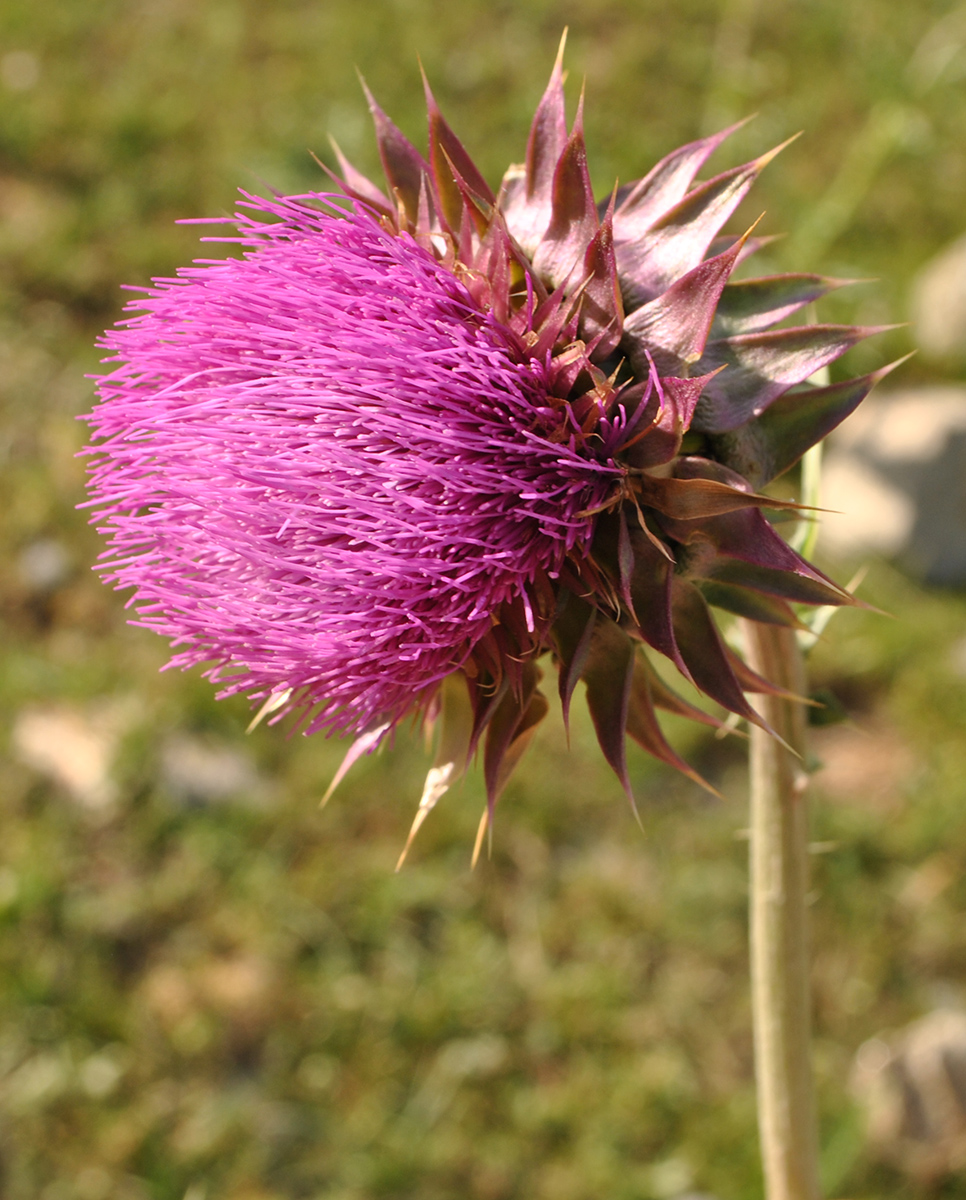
[0, 0, 966, 1200]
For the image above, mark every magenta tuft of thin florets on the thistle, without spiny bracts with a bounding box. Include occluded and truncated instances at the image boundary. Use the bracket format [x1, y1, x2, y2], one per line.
[91, 196, 622, 733]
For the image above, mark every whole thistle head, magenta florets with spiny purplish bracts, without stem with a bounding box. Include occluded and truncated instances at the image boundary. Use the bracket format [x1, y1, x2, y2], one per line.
[89, 44, 884, 844]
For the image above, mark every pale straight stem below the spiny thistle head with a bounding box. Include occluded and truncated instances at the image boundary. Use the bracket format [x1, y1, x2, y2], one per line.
[743, 622, 818, 1200]
